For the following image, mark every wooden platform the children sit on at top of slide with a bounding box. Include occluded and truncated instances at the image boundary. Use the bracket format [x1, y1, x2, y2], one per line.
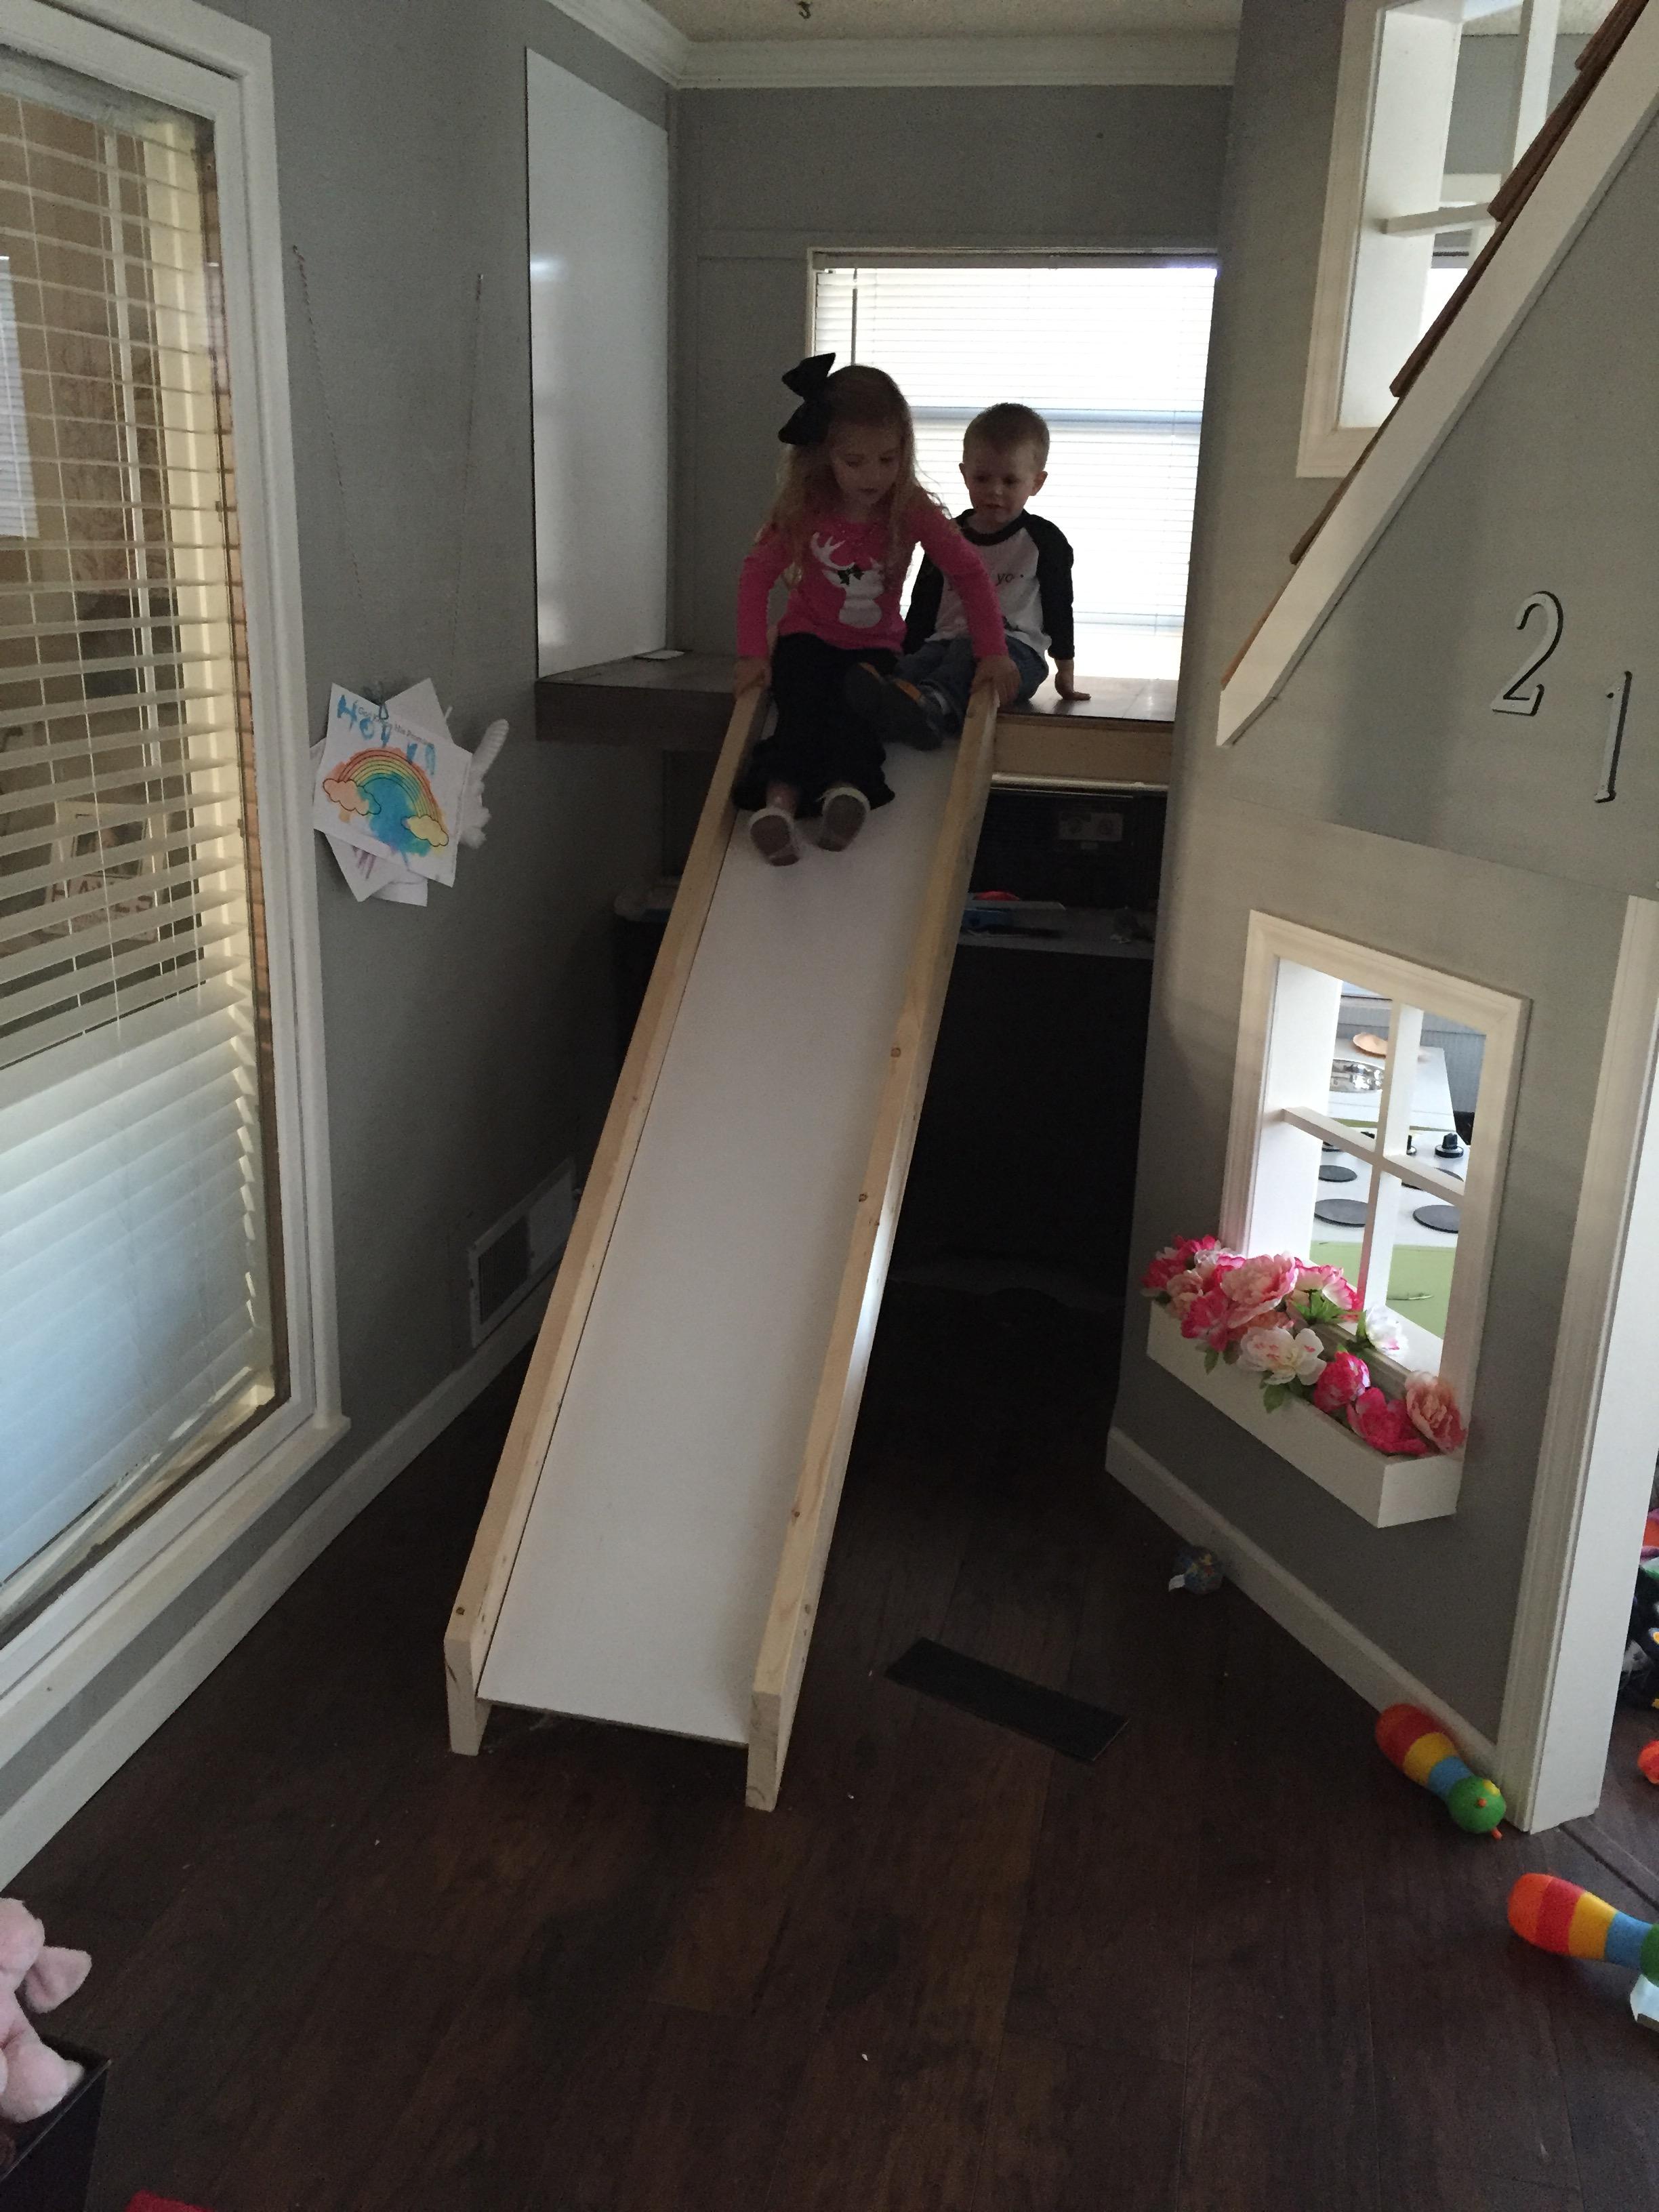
[535, 653, 1174, 790]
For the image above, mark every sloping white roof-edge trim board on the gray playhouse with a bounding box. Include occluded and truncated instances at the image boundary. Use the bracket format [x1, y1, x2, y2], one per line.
[1216, 9, 1659, 745]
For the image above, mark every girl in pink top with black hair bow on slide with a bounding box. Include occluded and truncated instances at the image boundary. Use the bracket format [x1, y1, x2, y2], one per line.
[735, 354, 1020, 867]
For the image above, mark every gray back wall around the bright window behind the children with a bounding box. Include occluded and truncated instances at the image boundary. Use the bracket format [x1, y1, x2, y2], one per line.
[675, 86, 1228, 653]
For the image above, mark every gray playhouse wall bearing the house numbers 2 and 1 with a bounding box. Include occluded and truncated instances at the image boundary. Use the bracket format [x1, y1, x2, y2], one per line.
[1117, 0, 1659, 1732]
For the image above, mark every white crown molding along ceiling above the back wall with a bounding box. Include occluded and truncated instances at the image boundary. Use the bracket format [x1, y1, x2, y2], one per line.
[539, 0, 1239, 91]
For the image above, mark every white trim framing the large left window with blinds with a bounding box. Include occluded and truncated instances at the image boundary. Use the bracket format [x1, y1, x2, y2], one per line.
[0, 0, 347, 1763]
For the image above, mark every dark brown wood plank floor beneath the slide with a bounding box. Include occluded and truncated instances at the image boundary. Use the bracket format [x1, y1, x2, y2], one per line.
[18, 1290, 1659, 2212]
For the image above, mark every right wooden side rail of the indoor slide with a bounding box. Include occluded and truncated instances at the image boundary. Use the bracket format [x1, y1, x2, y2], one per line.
[747, 690, 998, 1811]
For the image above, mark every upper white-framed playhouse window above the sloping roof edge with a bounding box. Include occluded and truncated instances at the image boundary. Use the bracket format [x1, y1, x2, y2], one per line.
[1298, 0, 1608, 476]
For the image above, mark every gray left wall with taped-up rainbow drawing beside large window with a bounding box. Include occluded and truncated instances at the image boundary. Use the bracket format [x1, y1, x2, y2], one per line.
[0, 0, 668, 1805]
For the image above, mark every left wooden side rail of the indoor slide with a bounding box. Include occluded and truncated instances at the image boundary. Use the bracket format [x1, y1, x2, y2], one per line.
[445, 690, 765, 1752]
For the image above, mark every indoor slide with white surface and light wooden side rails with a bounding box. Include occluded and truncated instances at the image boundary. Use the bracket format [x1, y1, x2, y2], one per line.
[445, 693, 996, 1809]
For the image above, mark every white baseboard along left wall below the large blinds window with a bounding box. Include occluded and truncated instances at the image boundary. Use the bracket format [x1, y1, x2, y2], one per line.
[0, 1285, 551, 1885]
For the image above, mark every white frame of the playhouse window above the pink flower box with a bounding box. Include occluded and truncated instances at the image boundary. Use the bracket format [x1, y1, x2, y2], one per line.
[1221, 914, 1526, 1414]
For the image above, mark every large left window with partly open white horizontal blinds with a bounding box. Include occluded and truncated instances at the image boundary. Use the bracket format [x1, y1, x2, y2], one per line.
[0, 49, 287, 1628]
